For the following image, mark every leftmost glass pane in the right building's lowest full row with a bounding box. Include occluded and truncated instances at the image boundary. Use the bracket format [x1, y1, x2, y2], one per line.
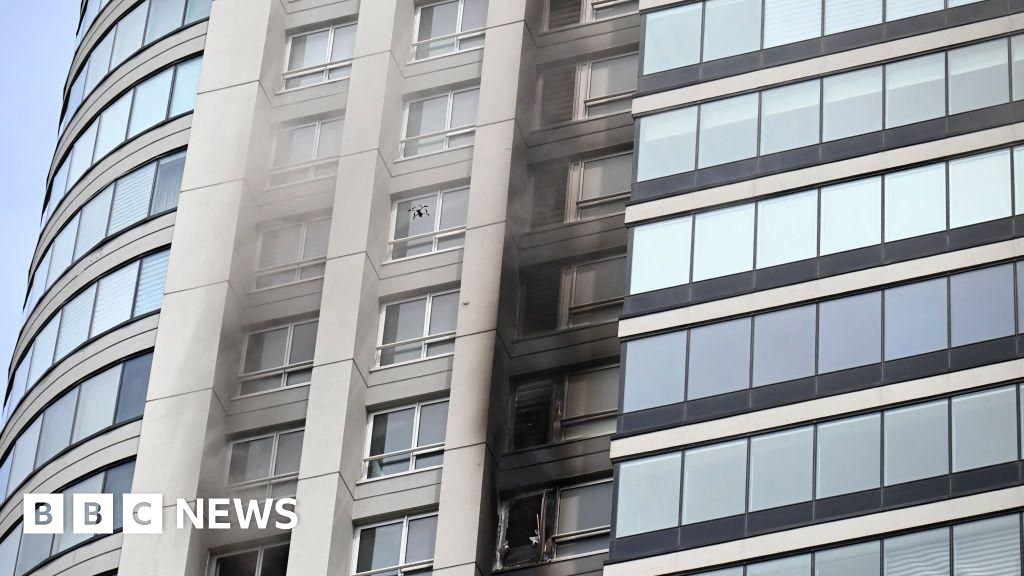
[615, 452, 682, 538]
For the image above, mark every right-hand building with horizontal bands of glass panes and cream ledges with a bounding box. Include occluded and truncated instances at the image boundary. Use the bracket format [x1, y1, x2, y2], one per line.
[604, 0, 1024, 576]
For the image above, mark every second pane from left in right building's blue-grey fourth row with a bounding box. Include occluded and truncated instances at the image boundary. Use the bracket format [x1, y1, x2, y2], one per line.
[686, 318, 751, 400]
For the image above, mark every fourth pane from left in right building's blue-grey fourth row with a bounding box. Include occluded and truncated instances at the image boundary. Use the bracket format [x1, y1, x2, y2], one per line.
[818, 292, 882, 373]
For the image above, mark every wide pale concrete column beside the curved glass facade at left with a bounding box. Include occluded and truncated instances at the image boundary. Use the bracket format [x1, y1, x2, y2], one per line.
[120, 0, 280, 576]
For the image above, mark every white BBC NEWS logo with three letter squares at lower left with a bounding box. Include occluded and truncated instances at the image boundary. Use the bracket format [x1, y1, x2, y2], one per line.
[23, 494, 299, 534]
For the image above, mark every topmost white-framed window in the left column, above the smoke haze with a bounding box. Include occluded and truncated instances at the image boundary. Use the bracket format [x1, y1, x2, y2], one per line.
[284, 24, 355, 90]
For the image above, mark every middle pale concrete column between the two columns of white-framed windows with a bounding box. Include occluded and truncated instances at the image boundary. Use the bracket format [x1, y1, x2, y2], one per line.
[288, 0, 401, 576]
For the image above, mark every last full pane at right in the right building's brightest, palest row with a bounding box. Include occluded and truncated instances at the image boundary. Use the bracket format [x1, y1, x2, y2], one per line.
[949, 150, 1013, 228]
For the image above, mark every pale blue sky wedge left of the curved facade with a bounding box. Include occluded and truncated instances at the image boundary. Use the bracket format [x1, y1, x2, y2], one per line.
[0, 0, 79, 373]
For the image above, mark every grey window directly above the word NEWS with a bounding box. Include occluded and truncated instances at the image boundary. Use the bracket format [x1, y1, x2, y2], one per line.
[227, 428, 304, 499]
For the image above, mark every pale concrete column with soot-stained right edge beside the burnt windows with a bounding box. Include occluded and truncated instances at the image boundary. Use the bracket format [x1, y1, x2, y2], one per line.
[433, 0, 525, 576]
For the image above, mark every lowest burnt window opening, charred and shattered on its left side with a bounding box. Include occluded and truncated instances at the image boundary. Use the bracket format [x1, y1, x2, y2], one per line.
[496, 478, 611, 568]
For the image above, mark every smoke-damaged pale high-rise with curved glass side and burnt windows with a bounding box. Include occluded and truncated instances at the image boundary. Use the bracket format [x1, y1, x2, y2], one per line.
[0, 0, 638, 576]
